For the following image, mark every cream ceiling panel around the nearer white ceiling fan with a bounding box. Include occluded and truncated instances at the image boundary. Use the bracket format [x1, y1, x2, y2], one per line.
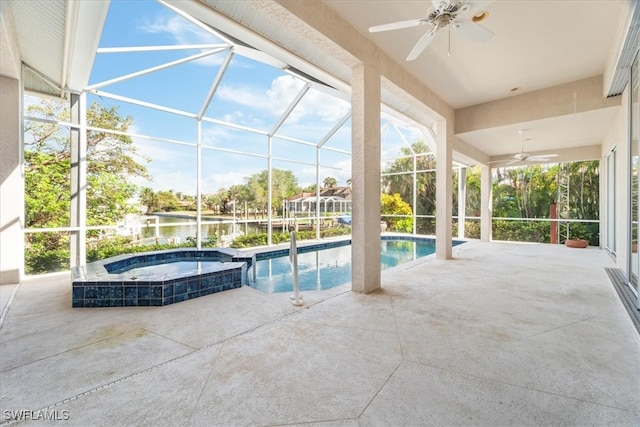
[325, 0, 625, 108]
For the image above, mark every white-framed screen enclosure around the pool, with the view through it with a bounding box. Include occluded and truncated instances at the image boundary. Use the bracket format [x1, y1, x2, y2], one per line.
[24, 2, 597, 274]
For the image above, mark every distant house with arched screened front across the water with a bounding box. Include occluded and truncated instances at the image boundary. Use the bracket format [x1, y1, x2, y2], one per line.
[286, 187, 351, 217]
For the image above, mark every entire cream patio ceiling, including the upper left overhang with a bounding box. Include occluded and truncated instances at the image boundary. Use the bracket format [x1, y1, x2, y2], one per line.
[0, 0, 638, 163]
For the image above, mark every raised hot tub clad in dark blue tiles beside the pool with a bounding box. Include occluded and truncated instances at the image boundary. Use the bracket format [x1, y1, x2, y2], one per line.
[71, 249, 255, 307]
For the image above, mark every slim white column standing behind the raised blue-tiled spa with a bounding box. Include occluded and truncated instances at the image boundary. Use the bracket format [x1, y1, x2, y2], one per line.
[70, 93, 87, 267]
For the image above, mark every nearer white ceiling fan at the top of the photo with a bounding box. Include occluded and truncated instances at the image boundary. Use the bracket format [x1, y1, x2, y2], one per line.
[369, 0, 494, 61]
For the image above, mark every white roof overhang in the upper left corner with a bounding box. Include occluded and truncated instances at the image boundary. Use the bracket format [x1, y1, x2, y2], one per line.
[0, 0, 109, 97]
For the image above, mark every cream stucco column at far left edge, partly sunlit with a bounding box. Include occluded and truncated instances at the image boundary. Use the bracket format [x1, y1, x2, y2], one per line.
[0, 76, 24, 285]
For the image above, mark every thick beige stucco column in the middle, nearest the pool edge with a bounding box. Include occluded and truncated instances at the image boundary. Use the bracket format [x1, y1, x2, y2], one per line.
[351, 64, 380, 293]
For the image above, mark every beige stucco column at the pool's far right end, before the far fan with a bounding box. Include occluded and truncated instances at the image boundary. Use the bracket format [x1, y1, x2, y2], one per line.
[436, 120, 453, 259]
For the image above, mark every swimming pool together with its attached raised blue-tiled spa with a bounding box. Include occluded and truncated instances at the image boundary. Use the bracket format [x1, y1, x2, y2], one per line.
[71, 236, 462, 307]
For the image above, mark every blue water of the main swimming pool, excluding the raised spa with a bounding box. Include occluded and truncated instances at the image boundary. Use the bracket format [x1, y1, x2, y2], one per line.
[251, 240, 435, 293]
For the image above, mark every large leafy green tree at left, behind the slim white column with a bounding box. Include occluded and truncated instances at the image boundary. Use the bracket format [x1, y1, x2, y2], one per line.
[24, 100, 149, 273]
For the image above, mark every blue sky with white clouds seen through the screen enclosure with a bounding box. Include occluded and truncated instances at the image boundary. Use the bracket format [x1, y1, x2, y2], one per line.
[87, 0, 423, 195]
